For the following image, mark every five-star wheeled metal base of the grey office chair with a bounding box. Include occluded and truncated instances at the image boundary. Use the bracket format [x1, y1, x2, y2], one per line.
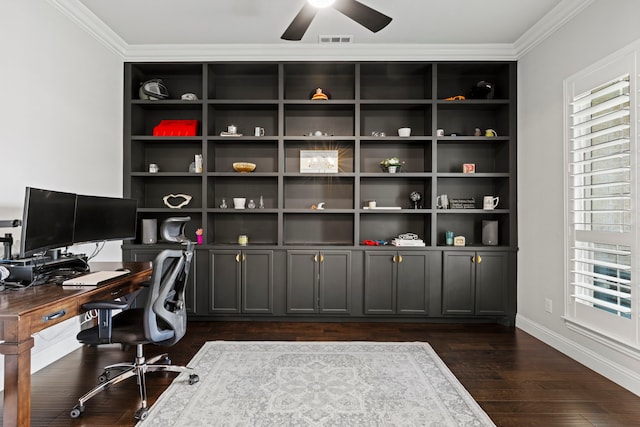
[69, 344, 200, 421]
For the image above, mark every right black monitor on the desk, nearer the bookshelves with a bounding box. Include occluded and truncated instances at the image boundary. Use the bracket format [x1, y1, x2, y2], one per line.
[73, 194, 138, 243]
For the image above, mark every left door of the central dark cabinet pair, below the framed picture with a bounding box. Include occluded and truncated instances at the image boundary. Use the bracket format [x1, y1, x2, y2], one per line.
[287, 251, 319, 313]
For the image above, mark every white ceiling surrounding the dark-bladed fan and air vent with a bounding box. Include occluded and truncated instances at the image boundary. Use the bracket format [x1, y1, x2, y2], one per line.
[49, 0, 592, 59]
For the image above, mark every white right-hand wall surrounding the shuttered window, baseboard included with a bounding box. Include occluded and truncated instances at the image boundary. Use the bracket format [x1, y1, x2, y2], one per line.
[517, 0, 640, 395]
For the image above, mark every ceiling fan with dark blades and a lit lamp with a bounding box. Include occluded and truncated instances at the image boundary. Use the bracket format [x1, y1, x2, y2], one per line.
[280, 0, 391, 40]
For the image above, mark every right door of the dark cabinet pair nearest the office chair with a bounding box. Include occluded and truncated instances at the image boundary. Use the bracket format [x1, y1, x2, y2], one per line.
[242, 250, 273, 314]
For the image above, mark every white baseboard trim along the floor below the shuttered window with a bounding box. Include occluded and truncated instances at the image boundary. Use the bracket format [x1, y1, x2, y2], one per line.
[516, 314, 640, 396]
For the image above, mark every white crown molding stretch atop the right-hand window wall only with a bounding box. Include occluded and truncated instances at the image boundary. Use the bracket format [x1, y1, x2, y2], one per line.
[513, 0, 594, 59]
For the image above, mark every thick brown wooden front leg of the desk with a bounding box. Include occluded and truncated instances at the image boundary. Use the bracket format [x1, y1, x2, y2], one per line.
[0, 337, 34, 427]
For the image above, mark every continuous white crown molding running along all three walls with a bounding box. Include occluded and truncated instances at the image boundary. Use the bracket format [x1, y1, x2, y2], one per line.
[46, 0, 594, 62]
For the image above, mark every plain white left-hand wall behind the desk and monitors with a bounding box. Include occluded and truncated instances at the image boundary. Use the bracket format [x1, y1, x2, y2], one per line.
[0, 0, 122, 386]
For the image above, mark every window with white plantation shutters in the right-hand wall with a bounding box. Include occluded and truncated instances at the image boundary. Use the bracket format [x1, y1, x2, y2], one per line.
[565, 48, 640, 352]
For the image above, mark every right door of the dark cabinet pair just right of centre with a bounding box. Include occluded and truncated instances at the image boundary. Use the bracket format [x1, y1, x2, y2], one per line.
[397, 252, 429, 314]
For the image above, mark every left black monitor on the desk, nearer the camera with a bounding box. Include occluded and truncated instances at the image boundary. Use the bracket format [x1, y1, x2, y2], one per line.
[20, 187, 76, 258]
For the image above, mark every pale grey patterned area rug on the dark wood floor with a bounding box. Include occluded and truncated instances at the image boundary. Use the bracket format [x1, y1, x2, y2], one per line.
[138, 341, 494, 427]
